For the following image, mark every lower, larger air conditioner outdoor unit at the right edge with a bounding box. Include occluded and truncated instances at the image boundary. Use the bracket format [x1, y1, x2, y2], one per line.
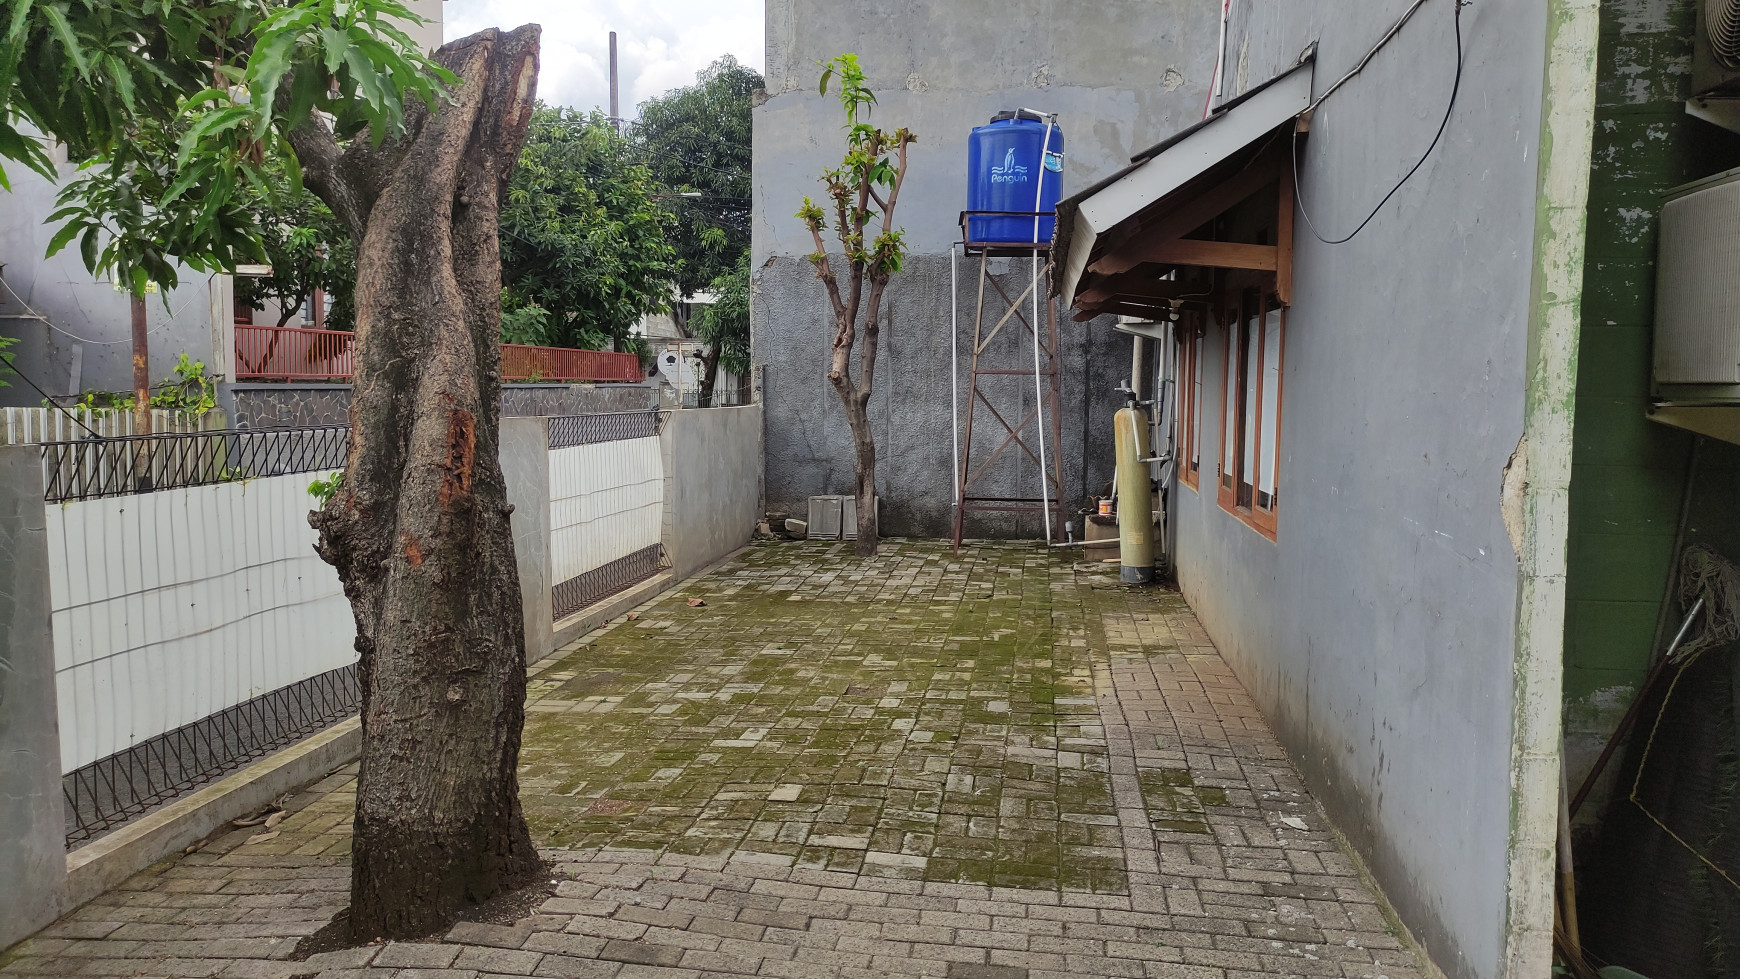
[1655, 169, 1740, 403]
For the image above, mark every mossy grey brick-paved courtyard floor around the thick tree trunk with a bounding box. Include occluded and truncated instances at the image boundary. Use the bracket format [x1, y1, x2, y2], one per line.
[0, 541, 1422, 979]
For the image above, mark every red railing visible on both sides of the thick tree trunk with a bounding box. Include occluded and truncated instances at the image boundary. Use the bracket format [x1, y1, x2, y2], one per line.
[235, 323, 646, 383]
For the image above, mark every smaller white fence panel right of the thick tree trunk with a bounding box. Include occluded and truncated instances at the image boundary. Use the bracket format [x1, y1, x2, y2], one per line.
[550, 436, 665, 584]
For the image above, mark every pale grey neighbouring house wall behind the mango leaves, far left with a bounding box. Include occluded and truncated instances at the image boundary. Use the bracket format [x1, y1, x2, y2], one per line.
[0, 163, 235, 405]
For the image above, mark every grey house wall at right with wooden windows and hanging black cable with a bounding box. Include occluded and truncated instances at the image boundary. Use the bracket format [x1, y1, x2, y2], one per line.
[1176, 0, 1550, 979]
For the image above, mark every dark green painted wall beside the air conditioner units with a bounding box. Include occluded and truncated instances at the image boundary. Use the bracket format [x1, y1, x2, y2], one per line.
[1564, 0, 1740, 786]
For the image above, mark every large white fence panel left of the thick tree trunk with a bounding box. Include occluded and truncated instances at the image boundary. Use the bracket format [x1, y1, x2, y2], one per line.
[47, 473, 357, 772]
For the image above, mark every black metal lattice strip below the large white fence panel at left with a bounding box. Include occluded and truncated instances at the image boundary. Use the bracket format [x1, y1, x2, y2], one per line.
[61, 664, 362, 849]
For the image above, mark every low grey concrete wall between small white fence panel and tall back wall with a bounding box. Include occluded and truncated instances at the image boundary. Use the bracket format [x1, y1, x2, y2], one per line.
[659, 405, 762, 579]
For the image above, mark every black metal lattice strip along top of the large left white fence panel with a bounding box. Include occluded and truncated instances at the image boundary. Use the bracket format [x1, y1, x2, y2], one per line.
[42, 426, 350, 503]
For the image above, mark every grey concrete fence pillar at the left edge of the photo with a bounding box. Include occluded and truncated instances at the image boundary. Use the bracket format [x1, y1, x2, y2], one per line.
[0, 445, 66, 949]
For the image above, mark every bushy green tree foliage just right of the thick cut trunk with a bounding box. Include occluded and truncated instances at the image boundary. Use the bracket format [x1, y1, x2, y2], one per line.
[501, 104, 677, 350]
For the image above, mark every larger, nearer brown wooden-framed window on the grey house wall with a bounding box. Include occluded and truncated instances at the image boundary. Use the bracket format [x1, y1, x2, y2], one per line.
[1218, 289, 1286, 539]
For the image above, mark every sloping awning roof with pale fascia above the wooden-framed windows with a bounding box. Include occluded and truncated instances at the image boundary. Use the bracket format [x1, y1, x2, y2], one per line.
[1051, 61, 1314, 304]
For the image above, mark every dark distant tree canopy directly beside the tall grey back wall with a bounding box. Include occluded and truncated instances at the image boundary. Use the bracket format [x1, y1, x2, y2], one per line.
[628, 54, 764, 296]
